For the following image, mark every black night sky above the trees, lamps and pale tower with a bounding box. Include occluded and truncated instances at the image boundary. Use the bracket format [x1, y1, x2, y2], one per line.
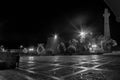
[0, 0, 120, 47]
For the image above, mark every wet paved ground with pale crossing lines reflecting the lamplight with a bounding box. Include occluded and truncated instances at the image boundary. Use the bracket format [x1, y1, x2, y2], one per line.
[0, 55, 120, 80]
